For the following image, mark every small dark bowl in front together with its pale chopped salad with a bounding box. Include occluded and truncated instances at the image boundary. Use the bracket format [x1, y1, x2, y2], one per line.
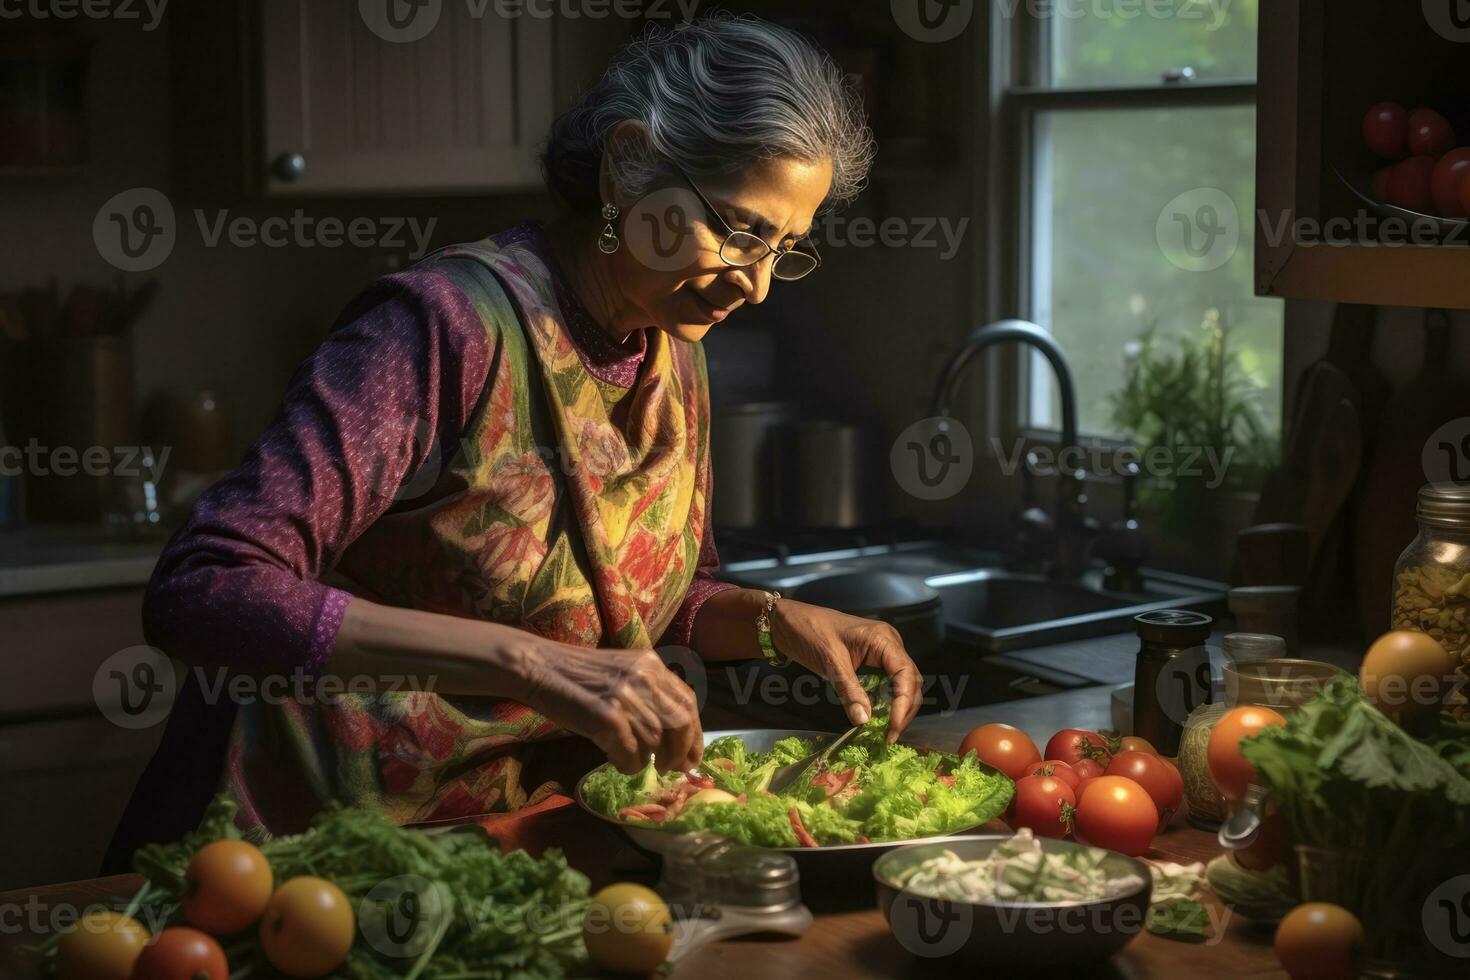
[873, 830, 1152, 968]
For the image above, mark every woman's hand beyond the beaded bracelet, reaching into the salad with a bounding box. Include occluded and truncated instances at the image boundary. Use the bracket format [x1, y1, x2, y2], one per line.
[770, 599, 923, 742]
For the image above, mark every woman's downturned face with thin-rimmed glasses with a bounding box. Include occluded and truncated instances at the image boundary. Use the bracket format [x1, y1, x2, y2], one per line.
[612, 157, 832, 341]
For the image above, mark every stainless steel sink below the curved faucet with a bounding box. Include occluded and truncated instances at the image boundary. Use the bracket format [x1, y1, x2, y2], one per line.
[725, 542, 1227, 654]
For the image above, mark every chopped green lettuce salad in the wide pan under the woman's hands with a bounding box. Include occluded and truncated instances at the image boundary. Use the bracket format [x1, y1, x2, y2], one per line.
[582, 716, 1014, 848]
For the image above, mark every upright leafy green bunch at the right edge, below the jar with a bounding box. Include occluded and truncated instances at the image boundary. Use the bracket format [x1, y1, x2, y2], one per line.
[1241, 674, 1470, 959]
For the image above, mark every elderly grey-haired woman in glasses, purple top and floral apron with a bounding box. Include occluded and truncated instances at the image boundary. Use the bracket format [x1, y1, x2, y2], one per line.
[115, 11, 919, 854]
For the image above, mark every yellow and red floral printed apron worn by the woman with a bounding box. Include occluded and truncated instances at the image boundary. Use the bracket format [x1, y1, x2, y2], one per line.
[223, 238, 710, 836]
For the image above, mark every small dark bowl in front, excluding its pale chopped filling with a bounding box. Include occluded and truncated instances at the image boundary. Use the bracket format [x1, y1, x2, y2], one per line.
[873, 835, 1154, 968]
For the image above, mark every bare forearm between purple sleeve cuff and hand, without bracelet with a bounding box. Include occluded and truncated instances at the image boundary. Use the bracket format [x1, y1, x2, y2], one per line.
[320, 598, 550, 701]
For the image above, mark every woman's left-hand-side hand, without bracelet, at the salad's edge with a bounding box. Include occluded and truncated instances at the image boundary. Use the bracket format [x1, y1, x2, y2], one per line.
[516, 645, 704, 773]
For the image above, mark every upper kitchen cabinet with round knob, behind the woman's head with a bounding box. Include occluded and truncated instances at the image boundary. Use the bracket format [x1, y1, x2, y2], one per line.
[172, 0, 631, 195]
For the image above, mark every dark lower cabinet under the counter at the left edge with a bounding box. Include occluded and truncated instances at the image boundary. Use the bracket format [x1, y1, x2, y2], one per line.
[0, 588, 163, 887]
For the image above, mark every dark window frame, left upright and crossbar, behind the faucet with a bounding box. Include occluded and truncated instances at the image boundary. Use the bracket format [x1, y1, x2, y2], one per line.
[978, 4, 1257, 448]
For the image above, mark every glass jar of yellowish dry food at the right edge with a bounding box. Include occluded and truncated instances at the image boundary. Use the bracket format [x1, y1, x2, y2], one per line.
[1389, 483, 1470, 696]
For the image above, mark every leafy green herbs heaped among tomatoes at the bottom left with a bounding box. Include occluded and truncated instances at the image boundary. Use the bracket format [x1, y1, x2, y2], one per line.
[61, 799, 588, 980]
